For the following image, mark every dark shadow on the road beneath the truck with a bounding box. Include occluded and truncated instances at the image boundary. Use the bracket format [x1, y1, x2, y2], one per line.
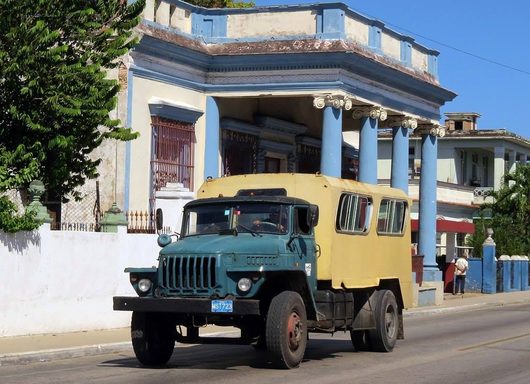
[98, 338, 358, 370]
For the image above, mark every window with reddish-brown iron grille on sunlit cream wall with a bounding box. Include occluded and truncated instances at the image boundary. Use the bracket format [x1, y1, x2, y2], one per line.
[151, 116, 195, 198]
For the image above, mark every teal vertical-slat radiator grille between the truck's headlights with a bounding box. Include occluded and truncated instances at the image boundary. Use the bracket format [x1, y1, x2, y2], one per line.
[162, 256, 216, 293]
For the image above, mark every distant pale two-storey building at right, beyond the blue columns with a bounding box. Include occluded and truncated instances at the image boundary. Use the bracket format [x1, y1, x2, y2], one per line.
[378, 112, 530, 262]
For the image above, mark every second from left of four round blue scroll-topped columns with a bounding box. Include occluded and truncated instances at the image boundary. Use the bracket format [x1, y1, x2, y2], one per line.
[359, 117, 379, 184]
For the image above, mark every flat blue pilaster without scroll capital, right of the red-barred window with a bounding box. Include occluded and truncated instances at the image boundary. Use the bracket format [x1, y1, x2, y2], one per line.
[204, 96, 220, 179]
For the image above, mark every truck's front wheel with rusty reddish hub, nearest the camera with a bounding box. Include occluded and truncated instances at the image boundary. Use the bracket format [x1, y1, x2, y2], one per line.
[265, 291, 307, 369]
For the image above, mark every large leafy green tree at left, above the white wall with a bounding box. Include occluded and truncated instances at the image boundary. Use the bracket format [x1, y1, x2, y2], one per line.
[0, 0, 145, 231]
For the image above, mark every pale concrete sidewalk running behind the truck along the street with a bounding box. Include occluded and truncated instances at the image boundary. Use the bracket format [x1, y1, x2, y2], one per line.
[0, 291, 530, 367]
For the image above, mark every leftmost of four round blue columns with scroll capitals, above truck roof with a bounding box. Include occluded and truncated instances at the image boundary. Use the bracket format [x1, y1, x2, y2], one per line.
[320, 106, 342, 177]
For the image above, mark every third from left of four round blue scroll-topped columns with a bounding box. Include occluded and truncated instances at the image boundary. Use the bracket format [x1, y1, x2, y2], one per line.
[390, 127, 409, 194]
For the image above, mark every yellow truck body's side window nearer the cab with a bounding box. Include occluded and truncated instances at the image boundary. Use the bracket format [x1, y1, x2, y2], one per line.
[336, 193, 372, 233]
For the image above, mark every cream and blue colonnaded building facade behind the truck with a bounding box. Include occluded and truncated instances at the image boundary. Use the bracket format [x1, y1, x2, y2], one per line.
[83, 0, 456, 279]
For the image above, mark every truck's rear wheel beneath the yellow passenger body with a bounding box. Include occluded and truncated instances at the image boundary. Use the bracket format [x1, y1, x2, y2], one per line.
[368, 289, 399, 352]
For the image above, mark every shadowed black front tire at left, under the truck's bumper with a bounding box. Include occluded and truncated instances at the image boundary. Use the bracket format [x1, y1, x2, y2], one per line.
[131, 312, 175, 366]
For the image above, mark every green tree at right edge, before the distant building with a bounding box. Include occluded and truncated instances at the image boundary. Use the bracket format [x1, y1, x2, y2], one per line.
[468, 164, 530, 255]
